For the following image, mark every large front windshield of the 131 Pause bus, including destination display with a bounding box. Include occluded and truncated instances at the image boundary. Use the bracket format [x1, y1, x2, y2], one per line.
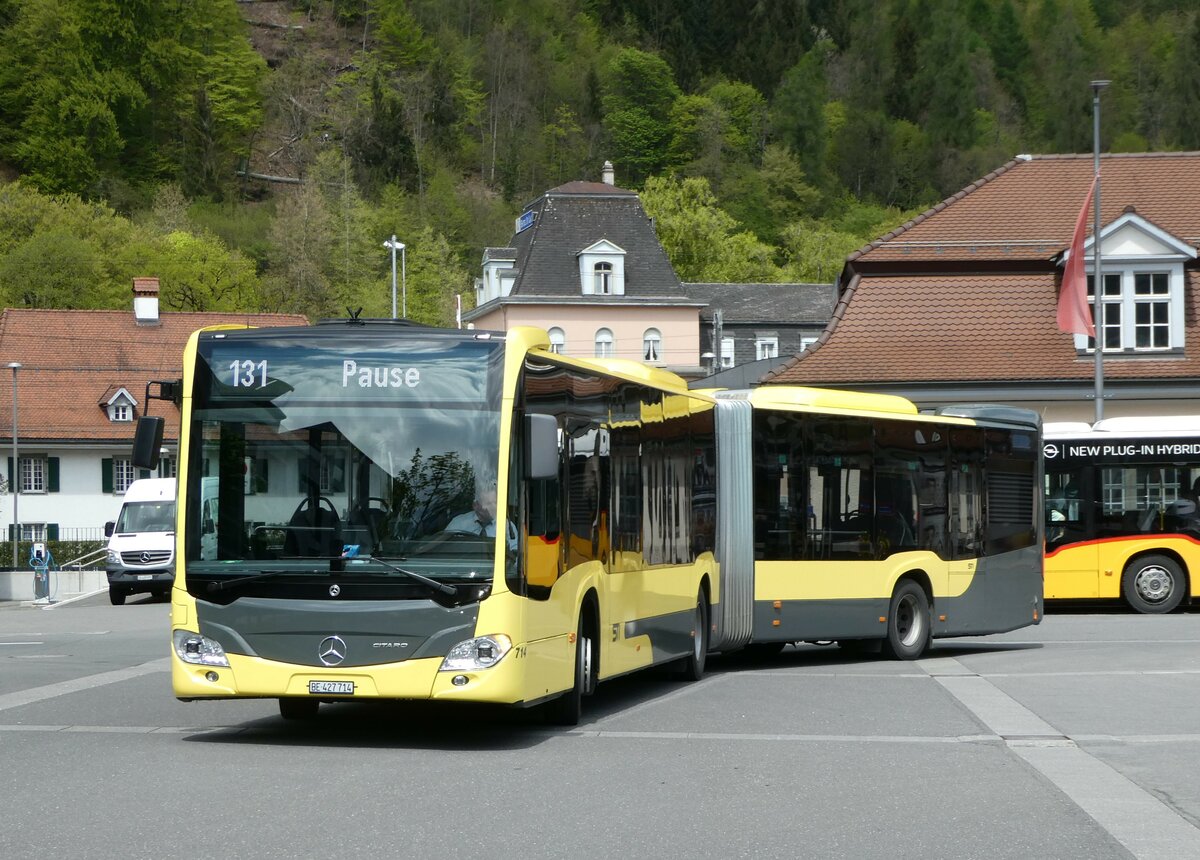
[185, 330, 503, 582]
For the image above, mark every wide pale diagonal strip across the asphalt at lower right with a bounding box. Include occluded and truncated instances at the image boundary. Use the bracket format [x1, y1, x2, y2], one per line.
[922, 661, 1200, 859]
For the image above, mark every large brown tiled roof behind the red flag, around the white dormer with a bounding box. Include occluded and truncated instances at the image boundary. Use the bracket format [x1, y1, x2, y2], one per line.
[762, 152, 1200, 386]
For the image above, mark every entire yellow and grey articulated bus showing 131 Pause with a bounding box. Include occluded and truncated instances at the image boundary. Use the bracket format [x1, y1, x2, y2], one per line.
[134, 319, 1042, 724]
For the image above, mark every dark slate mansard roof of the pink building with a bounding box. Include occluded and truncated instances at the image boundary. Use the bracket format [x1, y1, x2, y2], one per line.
[511, 182, 686, 300]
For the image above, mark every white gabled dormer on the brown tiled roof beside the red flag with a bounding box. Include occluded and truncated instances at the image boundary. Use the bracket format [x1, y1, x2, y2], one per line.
[1075, 212, 1196, 355]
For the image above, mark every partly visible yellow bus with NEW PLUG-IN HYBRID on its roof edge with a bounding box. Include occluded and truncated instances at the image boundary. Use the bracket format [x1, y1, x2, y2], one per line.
[1045, 415, 1200, 613]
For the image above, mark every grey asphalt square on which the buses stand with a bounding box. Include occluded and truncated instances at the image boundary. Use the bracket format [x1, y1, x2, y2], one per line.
[0, 595, 1200, 860]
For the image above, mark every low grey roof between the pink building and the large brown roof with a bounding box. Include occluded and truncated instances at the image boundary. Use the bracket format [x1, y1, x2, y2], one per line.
[683, 283, 838, 325]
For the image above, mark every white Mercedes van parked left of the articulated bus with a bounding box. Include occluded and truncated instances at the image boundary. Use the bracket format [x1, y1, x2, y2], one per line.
[104, 477, 175, 606]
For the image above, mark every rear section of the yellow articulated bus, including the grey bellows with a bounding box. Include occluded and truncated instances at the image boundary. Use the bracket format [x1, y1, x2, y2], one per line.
[715, 386, 1043, 660]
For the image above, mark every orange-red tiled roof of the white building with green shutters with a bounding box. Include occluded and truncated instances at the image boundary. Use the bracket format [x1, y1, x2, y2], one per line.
[0, 308, 308, 444]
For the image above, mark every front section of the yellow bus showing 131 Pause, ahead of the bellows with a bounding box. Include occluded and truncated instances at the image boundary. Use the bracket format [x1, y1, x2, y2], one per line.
[134, 320, 719, 723]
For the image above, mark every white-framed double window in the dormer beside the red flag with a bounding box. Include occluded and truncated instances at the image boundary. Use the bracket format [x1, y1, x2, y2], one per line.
[1087, 271, 1183, 353]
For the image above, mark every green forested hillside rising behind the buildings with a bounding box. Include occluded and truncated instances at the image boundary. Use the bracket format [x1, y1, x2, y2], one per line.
[0, 0, 1200, 323]
